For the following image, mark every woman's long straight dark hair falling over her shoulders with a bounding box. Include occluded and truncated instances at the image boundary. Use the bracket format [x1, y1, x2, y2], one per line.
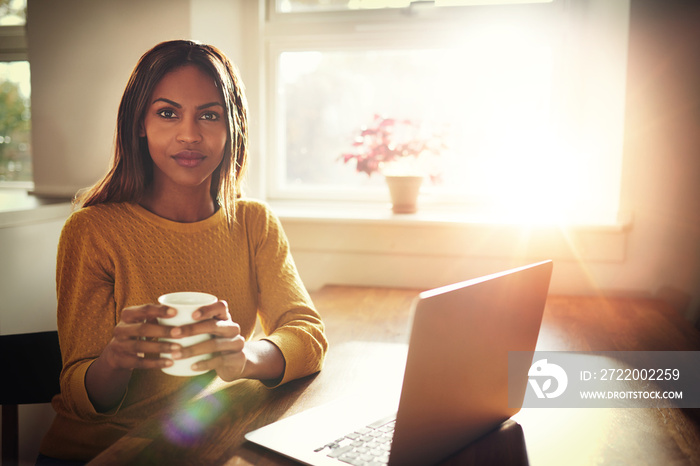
[76, 40, 248, 221]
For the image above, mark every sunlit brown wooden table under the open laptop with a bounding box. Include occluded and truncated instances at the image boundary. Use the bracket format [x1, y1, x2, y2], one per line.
[91, 286, 700, 466]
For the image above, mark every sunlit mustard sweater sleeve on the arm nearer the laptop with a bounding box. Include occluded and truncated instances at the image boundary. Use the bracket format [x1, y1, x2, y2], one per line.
[247, 202, 328, 385]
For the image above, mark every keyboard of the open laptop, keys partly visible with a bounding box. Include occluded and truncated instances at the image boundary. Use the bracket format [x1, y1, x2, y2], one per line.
[314, 414, 396, 466]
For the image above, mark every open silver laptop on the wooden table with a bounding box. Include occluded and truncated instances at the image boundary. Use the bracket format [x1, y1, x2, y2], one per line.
[245, 261, 552, 466]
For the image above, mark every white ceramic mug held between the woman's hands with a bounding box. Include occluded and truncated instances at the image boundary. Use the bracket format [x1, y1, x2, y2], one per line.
[158, 291, 218, 377]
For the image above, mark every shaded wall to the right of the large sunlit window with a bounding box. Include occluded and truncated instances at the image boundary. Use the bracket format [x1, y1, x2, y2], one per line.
[620, 0, 700, 326]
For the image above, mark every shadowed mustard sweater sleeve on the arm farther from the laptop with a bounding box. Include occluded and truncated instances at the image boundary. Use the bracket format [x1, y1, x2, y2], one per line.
[56, 211, 126, 420]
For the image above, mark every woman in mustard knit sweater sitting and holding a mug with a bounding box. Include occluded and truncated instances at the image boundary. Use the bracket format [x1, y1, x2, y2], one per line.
[38, 41, 327, 463]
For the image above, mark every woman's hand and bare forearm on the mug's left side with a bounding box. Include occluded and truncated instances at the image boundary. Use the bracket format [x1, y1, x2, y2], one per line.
[85, 304, 182, 413]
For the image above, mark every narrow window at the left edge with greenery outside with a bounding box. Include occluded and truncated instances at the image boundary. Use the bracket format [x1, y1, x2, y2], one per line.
[0, 0, 32, 187]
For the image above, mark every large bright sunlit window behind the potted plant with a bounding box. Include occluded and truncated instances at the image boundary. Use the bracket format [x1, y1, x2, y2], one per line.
[265, 0, 629, 226]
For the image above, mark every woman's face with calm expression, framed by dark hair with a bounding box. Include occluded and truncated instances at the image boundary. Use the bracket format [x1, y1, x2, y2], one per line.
[140, 65, 228, 197]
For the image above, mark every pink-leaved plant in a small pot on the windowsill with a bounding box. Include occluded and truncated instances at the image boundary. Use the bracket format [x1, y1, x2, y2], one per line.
[341, 115, 446, 213]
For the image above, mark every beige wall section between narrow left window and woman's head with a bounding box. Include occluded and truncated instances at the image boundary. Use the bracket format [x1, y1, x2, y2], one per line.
[27, 0, 191, 196]
